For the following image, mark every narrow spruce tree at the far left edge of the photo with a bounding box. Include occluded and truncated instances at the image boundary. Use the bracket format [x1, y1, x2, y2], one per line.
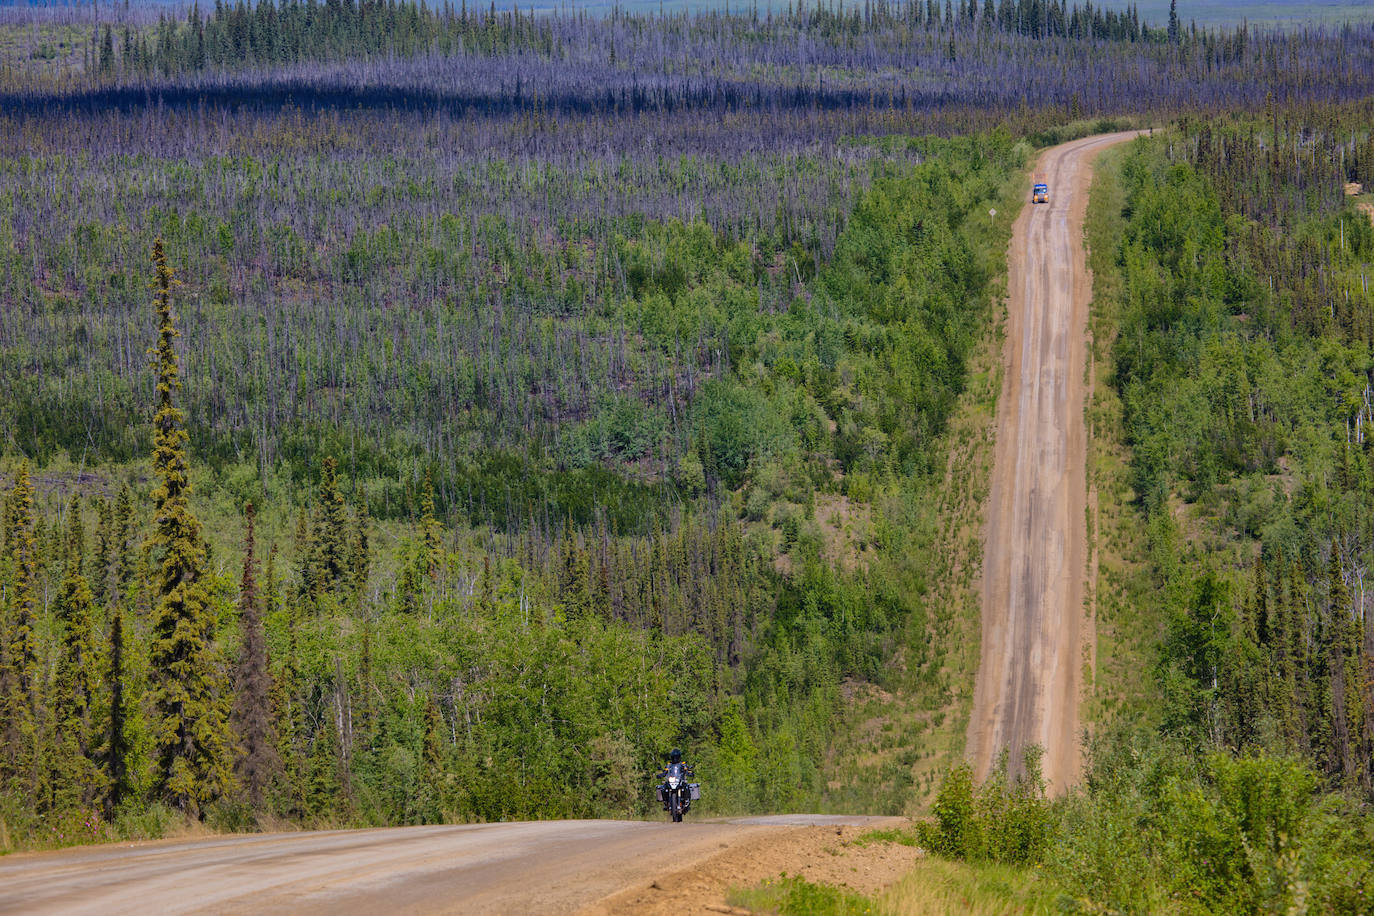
[0, 461, 38, 803]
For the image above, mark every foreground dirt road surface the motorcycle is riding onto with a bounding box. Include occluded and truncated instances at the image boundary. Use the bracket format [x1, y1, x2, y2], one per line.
[0, 816, 910, 916]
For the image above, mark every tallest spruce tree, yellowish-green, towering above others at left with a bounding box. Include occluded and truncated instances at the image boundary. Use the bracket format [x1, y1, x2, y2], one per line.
[148, 239, 232, 817]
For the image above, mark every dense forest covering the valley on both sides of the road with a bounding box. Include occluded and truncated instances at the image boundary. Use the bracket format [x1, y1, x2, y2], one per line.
[0, 0, 1374, 912]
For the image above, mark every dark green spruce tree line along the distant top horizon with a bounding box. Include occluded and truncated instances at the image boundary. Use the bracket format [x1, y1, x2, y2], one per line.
[87, 0, 1148, 77]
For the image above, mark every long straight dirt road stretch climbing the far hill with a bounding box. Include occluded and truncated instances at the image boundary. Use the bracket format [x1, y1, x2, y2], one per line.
[967, 132, 1136, 792]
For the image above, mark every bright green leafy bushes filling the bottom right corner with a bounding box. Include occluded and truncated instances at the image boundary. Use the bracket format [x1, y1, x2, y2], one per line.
[1048, 732, 1374, 913]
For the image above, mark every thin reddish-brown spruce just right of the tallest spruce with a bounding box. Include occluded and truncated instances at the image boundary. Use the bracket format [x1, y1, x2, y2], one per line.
[231, 503, 280, 810]
